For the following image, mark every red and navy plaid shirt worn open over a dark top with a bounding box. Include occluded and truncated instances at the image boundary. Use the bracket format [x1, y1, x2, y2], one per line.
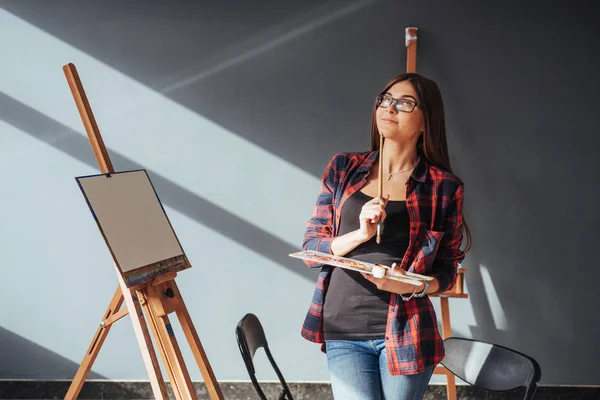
[302, 151, 465, 375]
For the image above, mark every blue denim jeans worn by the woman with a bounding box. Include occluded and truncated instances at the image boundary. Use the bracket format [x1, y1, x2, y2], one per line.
[325, 339, 433, 400]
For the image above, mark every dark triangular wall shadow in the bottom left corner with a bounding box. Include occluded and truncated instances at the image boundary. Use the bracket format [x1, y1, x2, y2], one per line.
[0, 326, 106, 380]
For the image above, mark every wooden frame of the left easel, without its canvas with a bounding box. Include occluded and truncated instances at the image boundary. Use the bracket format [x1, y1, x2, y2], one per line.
[63, 64, 223, 400]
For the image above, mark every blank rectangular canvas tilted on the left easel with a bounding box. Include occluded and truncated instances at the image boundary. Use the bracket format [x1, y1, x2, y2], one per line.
[76, 170, 183, 273]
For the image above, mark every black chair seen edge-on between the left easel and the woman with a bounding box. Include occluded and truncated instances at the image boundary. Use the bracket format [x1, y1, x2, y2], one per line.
[235, 314, 294, 400]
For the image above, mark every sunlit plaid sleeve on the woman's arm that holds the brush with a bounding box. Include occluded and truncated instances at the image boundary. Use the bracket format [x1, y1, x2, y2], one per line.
[302, 156, 337, 268]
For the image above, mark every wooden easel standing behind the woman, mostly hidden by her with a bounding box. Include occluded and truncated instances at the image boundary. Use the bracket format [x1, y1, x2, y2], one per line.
[405, 27, 469, 400]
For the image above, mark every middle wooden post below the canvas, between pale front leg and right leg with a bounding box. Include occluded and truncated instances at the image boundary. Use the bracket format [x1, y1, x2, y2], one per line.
[138, 287, 198, 400]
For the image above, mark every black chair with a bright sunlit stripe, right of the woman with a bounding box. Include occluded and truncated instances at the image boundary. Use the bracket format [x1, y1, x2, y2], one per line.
[441, 337, 542, 400]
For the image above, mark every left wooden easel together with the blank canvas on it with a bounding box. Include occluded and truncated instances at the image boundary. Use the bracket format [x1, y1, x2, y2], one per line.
[63, 64, 223, 400]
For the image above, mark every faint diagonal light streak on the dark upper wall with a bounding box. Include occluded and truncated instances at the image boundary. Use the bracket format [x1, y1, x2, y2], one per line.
[160, 0, 380, 94]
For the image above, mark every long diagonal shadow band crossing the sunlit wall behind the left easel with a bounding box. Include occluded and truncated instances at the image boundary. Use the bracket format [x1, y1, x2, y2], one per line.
[0, 93, 318, 281]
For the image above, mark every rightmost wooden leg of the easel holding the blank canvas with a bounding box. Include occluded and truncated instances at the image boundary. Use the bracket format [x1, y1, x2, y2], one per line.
[169, 281, 223, 400]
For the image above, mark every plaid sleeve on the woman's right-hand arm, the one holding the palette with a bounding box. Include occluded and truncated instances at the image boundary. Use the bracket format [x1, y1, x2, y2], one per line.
[432, 184, 465, 293]
